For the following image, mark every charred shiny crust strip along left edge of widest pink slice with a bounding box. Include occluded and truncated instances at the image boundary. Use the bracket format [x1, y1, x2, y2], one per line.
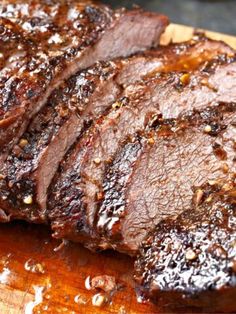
[95, 131, 147, 250]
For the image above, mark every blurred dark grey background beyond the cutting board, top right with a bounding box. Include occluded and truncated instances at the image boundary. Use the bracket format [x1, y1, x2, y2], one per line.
[103, 0, 236, 36]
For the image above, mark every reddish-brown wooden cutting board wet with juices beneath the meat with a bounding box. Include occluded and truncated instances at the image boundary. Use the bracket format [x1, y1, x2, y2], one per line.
[0, 24, 236, 314]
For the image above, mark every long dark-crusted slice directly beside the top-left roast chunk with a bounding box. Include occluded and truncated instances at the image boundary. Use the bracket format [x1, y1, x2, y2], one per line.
[0, 38, 230, 222]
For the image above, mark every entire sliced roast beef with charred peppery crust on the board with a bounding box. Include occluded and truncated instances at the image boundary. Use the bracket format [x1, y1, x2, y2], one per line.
[0, 0, 236, 312]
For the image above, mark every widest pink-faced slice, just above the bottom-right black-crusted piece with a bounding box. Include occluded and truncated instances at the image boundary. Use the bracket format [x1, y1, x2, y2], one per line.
[100, 105, 236, 255]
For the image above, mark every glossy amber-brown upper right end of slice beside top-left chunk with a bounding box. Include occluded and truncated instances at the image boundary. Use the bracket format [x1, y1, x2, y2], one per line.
[116, 35, 235, 85]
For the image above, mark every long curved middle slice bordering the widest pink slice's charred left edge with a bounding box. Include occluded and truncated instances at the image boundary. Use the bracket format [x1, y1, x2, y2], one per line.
[48, 55, 236, 250]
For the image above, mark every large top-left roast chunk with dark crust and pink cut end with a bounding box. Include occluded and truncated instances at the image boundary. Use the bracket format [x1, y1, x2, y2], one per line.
[0, 0, 168, 160]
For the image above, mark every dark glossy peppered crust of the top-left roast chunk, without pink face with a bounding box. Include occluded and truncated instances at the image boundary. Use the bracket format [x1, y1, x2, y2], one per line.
[0, 1, 112, 149]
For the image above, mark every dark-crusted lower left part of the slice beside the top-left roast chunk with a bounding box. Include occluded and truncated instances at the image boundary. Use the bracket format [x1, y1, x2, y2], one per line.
[0, 62, 120, 221]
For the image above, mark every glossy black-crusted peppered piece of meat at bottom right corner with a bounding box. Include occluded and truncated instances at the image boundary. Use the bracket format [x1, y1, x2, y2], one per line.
[135, 181, 236, 313]
